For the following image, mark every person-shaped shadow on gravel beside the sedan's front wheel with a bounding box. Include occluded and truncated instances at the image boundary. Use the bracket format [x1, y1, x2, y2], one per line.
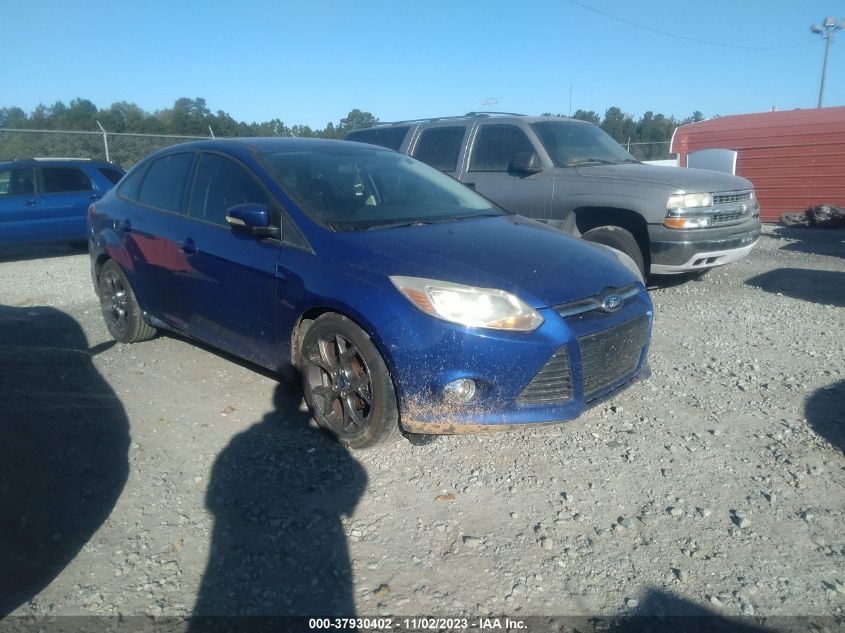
[192, 383, 367, 616]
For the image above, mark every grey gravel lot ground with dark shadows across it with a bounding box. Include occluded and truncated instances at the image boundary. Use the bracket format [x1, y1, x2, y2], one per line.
[0, 227, 845, 618]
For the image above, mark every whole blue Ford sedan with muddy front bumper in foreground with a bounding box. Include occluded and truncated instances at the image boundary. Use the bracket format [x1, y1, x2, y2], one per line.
[88, 138, 652, 448]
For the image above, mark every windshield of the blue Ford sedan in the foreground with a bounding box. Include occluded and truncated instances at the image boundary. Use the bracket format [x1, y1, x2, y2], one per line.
[263, 148, 505, 231]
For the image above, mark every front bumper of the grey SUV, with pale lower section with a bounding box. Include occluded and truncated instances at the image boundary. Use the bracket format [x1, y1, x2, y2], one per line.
[648, 218, 761, 275]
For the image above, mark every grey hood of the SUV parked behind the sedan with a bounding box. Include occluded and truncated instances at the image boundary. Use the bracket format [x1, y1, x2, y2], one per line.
[570, 163, 753, 193]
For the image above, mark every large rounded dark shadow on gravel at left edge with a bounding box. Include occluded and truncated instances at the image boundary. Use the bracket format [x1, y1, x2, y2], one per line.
[0, 305, 129, 618]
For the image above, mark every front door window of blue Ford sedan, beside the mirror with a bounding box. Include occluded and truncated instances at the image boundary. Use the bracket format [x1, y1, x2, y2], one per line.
[190, 154, 270, 226]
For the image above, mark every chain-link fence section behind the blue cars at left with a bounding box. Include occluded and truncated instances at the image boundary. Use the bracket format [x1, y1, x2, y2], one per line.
[0, 128, 216, 169]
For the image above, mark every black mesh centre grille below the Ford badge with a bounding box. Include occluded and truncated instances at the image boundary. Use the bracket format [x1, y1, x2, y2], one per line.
[578, 314, 648, 401]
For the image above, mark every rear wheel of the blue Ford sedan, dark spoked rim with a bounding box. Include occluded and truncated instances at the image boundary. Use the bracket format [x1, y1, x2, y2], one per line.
[97, 259, 156, 343]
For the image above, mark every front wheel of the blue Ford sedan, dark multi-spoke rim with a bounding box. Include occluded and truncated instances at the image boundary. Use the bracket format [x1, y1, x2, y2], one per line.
[299, 313, 399, 448]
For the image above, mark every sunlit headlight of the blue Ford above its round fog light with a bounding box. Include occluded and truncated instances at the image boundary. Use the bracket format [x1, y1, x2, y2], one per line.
[390, 276, 543, 332]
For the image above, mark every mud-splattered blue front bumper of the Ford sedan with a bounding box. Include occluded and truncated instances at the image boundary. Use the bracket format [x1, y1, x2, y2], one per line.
[377, 288, 652, 434]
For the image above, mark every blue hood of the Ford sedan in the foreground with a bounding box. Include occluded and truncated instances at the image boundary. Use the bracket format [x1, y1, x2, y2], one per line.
[324, 215, 638, 308]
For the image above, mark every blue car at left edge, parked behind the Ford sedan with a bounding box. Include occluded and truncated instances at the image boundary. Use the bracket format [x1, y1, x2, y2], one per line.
[0, 158, 124, 244]
